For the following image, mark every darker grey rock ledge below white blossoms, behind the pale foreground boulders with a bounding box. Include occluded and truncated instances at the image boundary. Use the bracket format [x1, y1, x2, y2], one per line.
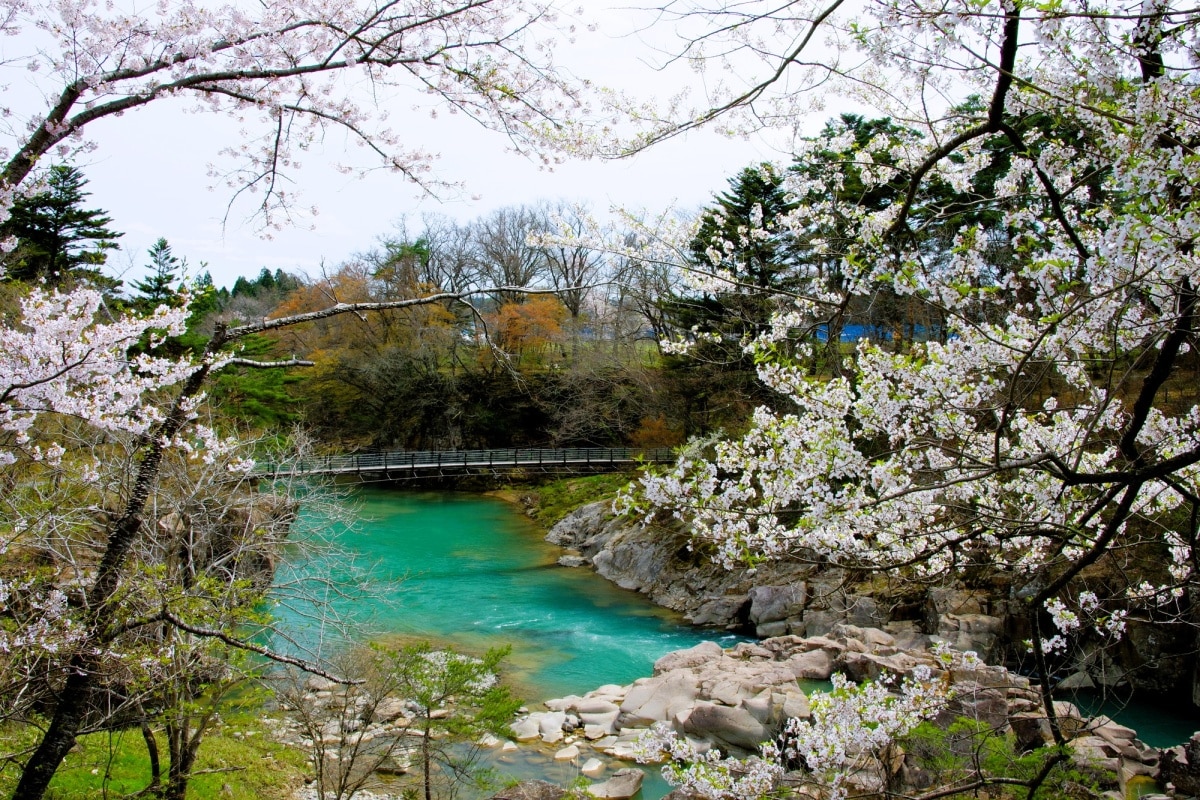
[546, 501, 1200, 704]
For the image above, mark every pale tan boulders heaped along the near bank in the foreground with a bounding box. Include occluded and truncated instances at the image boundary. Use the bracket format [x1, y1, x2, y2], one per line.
[512, 624, 1171, 800]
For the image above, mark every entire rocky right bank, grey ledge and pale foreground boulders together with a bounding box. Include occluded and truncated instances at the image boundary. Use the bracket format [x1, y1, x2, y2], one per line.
[525, 501, 1200, 798]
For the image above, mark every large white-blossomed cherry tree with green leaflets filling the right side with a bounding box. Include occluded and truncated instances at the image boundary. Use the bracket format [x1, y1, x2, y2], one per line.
[604, 0, 1200, 796]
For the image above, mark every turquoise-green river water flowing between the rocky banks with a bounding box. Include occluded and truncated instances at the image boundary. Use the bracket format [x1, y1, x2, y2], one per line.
[278, 486, 1196, 800]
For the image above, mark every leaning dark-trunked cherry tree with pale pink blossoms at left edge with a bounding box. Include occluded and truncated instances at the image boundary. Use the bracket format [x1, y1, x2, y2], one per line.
[0, 289, 537, 798]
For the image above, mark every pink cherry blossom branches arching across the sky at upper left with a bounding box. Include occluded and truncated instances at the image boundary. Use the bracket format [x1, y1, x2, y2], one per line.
[0, 0, 583, 228]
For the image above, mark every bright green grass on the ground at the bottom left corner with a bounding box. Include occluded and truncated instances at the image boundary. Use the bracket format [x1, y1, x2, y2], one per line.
[0, 714, 308, 800]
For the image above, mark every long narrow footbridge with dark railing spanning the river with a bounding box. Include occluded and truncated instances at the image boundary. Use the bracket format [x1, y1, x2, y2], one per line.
[256, 447, 674, 475]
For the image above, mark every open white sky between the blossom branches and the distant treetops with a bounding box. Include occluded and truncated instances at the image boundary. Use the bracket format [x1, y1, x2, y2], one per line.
[37, 8, 806, 287]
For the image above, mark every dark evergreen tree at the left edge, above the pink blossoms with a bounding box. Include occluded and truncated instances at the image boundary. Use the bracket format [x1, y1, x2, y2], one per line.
[0, 164, 122, 290]
